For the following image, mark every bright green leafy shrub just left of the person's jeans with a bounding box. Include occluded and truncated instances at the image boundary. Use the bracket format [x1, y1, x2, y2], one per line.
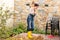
[12, 23, 27, 34]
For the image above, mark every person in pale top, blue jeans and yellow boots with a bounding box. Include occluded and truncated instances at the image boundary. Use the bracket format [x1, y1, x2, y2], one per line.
[27, 2, 39, 38]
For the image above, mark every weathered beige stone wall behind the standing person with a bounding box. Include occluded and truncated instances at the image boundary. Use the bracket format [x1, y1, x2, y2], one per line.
[14, 0, 60, 28]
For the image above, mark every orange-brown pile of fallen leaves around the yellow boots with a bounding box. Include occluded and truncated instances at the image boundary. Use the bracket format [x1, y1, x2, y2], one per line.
[6, 33, 44, 40]
